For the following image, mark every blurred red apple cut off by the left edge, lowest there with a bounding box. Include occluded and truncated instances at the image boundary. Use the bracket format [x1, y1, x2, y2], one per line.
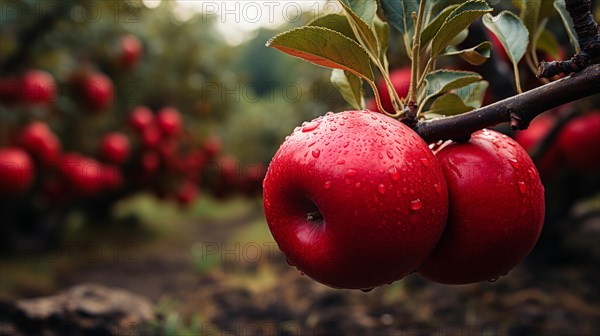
[0, 147, 34, 196]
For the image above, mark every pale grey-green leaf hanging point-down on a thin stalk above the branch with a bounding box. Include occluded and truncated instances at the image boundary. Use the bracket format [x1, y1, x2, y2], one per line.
[483, 11, 529, 67]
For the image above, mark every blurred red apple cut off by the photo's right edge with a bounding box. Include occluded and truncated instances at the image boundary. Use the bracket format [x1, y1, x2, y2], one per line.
[558, 110, 600, 172]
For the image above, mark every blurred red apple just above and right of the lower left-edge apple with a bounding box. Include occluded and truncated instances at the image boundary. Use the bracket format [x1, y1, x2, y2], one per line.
[19, 121, 61, 166]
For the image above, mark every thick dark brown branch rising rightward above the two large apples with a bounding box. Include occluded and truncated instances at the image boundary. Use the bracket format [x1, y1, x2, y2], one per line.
[414, 65, 600, 143]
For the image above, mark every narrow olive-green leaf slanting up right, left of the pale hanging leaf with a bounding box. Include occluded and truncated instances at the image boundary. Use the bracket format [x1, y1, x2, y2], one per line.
[431, 0, 492, 58]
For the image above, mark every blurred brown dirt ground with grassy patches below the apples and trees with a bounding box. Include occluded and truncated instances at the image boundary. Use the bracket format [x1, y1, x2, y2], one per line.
[0, 197, 600, 336]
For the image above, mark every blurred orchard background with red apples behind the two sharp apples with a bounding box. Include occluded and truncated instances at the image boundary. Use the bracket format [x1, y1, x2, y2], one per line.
[0, 0, 600, 335]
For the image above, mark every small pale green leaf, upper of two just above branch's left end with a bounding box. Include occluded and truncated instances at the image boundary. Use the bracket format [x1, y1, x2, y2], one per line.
[425, 70, 482, 101]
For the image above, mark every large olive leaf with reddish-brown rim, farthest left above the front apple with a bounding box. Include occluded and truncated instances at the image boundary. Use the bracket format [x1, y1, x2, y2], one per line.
[267, 26, 374, 81]
